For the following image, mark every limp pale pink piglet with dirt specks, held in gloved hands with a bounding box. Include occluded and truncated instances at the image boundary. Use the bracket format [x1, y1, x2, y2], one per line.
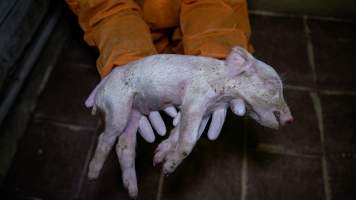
[86, 47, 293, 197]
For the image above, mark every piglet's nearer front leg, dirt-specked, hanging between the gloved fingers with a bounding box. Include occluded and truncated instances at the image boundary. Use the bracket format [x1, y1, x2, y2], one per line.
[163, 88, 214, 175]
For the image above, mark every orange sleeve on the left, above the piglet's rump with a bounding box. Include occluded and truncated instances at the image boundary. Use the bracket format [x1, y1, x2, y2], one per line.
[67, 0, 156, 77]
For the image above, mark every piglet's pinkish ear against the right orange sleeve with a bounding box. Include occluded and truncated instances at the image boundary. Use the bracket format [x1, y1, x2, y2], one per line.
[225, 46, 255, 76]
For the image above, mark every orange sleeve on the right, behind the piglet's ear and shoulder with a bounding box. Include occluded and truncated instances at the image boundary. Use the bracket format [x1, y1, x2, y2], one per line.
[180, 0, 250, 58]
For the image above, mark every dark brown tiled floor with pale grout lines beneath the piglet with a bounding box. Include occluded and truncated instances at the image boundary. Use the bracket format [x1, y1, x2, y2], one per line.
[1, 10, 356, 200]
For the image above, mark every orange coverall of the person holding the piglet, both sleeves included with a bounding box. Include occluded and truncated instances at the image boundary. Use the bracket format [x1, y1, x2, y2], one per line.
[67, 0, 252, 77]
